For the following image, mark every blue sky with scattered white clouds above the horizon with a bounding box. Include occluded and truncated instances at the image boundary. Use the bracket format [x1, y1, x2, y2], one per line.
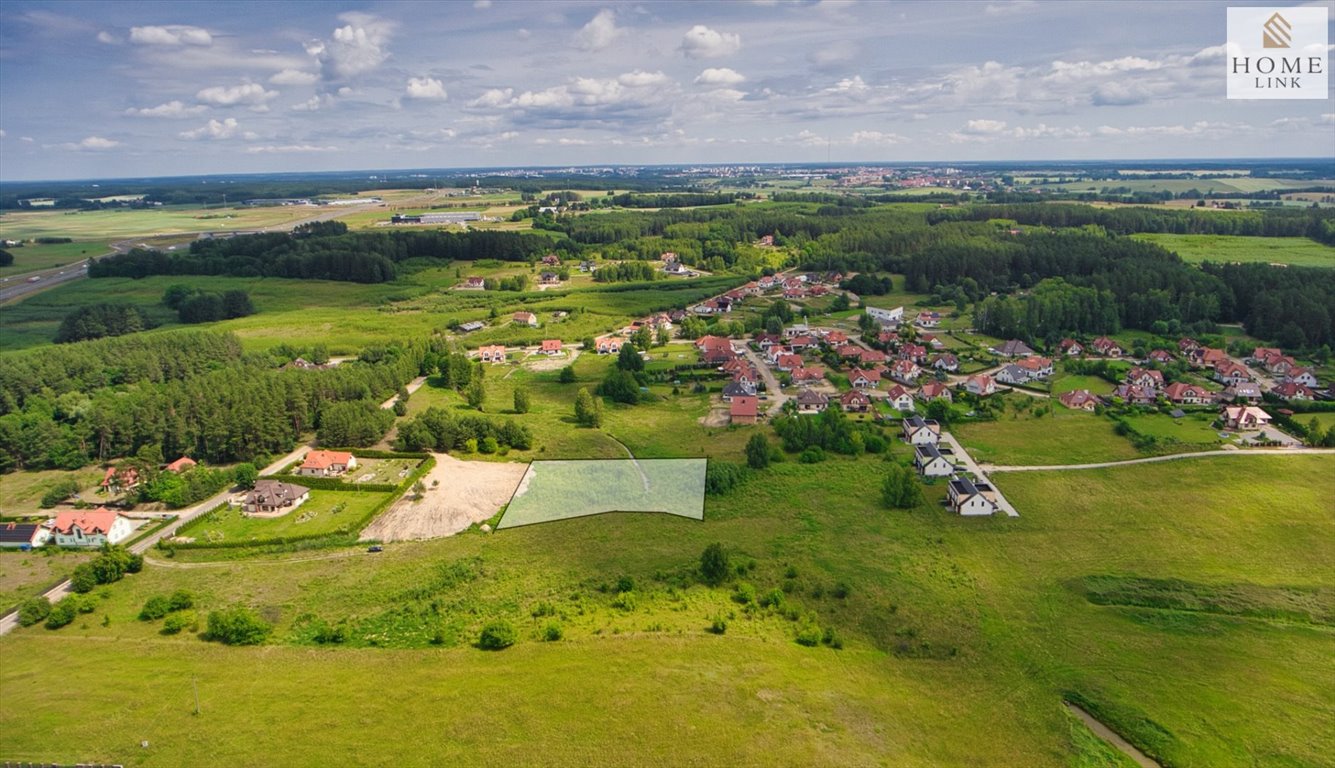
[0, 0, 1335, 180]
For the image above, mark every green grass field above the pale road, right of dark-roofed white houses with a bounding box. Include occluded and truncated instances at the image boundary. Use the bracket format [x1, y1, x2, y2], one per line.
[951, 401, 1140, 465]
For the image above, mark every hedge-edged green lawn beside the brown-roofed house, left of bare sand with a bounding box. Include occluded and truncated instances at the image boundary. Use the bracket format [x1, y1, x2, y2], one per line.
[180, 490, 384, 544]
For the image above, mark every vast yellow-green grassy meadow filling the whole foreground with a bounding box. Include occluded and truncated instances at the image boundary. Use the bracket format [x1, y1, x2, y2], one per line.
[0, 449, 1335, 767]
